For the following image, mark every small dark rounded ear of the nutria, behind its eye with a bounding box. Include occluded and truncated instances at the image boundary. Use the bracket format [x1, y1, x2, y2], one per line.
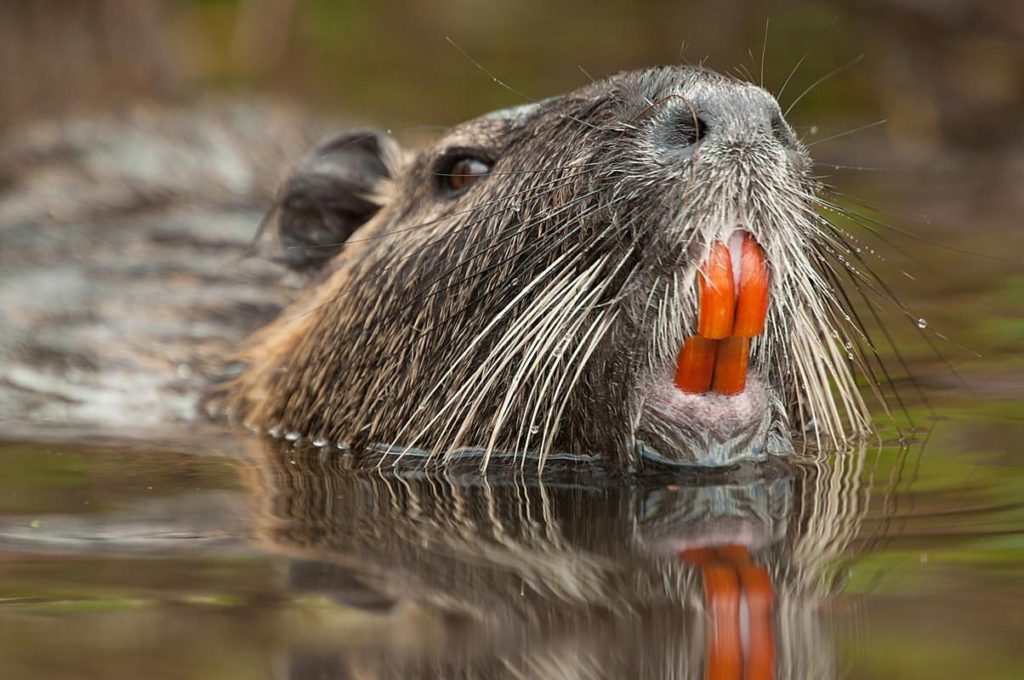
[253, 130, 400, 270]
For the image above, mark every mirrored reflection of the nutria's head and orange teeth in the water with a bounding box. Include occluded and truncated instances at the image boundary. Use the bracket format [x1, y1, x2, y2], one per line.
[243, 448, 867, 679]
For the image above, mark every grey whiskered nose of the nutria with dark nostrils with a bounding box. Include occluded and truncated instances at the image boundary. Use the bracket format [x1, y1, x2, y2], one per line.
[662, 85, 798, 151]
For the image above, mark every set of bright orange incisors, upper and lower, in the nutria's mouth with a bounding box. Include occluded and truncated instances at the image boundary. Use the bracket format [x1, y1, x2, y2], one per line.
[675, 232, 769, 395]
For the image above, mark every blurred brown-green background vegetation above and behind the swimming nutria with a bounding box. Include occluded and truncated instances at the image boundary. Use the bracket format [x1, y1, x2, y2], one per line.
[0, 0, 1024, 144]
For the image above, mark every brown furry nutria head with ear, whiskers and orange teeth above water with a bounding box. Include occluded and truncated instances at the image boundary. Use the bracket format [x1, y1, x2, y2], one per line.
[219, 67, 867, 471]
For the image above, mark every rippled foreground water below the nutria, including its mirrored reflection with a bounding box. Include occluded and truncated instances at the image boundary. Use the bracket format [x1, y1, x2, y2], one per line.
[0, 399, 1024, 678]
